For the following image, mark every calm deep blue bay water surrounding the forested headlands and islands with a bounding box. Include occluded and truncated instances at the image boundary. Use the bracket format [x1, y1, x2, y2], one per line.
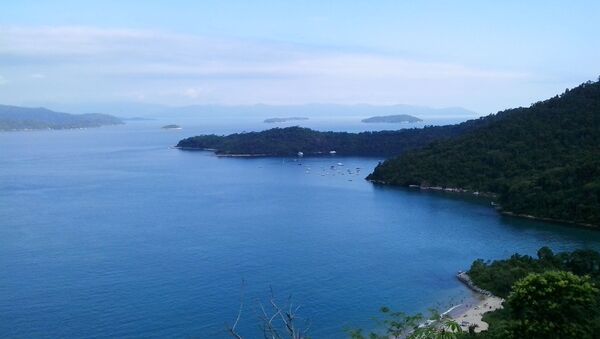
[0, 121, 600, 338]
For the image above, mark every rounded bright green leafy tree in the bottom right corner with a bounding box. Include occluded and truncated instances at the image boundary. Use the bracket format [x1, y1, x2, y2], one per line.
[508, 271, 599, 338]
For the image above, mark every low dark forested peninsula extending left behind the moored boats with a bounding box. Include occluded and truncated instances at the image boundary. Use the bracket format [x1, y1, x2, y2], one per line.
[177, 116, 496, 156]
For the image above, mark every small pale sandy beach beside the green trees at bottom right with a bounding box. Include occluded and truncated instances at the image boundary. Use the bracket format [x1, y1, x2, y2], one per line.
[447, 272, 504, 333]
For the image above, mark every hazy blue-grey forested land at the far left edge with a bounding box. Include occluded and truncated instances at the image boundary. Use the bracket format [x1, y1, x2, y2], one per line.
[0, 105, 123, 131]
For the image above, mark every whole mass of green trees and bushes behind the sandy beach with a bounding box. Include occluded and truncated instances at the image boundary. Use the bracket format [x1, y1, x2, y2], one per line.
[469, 247, 600, 338]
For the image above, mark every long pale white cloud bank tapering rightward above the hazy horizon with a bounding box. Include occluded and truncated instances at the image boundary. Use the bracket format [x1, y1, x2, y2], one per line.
[0, 26, 531, 110]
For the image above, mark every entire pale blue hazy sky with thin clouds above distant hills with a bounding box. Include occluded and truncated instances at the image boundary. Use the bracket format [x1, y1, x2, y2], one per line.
[0, 0, 600, 113]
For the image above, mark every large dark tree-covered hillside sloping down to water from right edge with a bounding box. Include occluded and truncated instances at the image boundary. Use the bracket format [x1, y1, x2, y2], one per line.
[368, 82, 600, 225]
